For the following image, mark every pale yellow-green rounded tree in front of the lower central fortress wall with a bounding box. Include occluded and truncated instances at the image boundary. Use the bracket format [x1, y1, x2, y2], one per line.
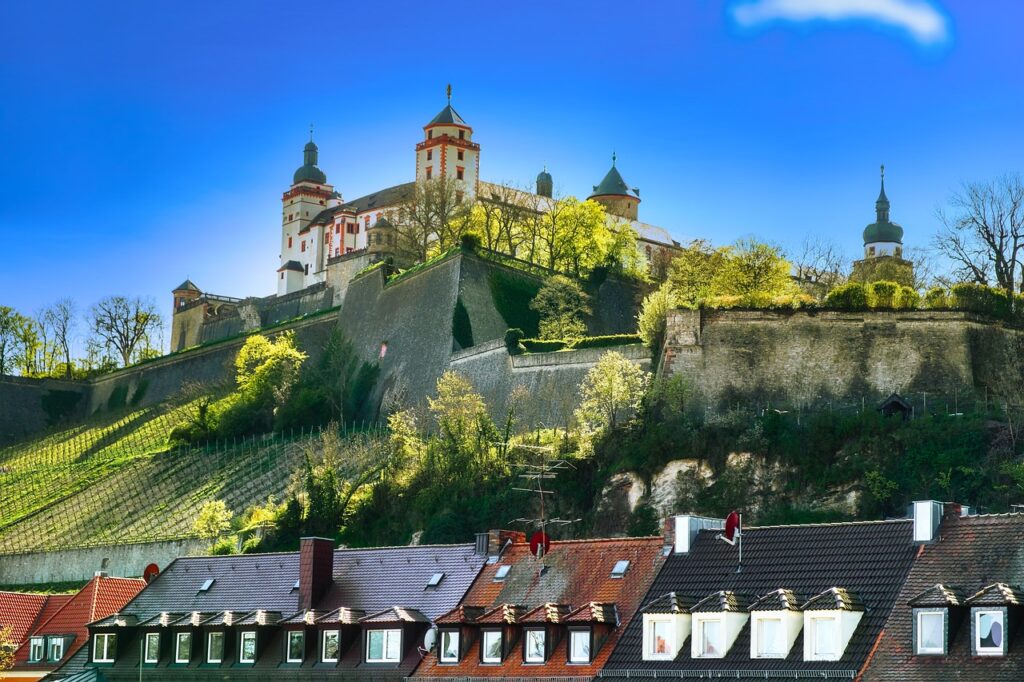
[575, 350, 649, 433]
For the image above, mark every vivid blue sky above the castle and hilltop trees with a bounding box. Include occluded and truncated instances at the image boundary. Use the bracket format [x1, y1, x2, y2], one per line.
[0, 0, 1024, 339]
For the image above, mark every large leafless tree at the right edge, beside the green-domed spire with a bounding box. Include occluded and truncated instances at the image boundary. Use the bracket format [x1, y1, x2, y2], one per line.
[935, 174, 1024, 293]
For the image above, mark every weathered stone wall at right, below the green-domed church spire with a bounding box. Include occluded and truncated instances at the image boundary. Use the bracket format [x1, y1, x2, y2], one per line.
[659, 310, 1020, 407]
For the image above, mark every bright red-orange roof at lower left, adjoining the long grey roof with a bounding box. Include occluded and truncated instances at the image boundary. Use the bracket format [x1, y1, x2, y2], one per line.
[14, 577, 145, 670]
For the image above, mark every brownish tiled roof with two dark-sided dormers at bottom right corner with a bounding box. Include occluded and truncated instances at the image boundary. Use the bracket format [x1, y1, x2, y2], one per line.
[864, 514, 1024, 682]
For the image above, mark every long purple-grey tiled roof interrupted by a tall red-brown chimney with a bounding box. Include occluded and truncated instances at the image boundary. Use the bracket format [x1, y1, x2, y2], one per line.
[114, 545, 484, 621]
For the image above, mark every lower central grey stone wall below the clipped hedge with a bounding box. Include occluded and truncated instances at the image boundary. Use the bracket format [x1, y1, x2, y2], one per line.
[450, 340, 651, 427]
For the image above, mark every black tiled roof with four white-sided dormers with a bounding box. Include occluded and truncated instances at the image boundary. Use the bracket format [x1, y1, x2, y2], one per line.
[601, 520, 918, 679]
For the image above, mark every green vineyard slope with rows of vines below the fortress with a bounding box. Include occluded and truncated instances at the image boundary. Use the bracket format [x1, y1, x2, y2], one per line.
[0, 406, 323, 553]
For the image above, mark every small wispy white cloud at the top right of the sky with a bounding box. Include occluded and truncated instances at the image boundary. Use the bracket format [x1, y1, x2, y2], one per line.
[732, 0, 948, 43]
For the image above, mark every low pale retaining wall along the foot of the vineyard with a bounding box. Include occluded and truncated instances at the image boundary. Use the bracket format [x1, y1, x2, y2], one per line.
[0, 540, 208, 585]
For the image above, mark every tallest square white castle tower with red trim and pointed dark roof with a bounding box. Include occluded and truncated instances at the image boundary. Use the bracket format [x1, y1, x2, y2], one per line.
[416, 84, 480, 199]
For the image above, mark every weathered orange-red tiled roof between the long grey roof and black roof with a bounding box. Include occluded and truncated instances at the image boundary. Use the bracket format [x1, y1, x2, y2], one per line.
[415, 538, 665, 679]
